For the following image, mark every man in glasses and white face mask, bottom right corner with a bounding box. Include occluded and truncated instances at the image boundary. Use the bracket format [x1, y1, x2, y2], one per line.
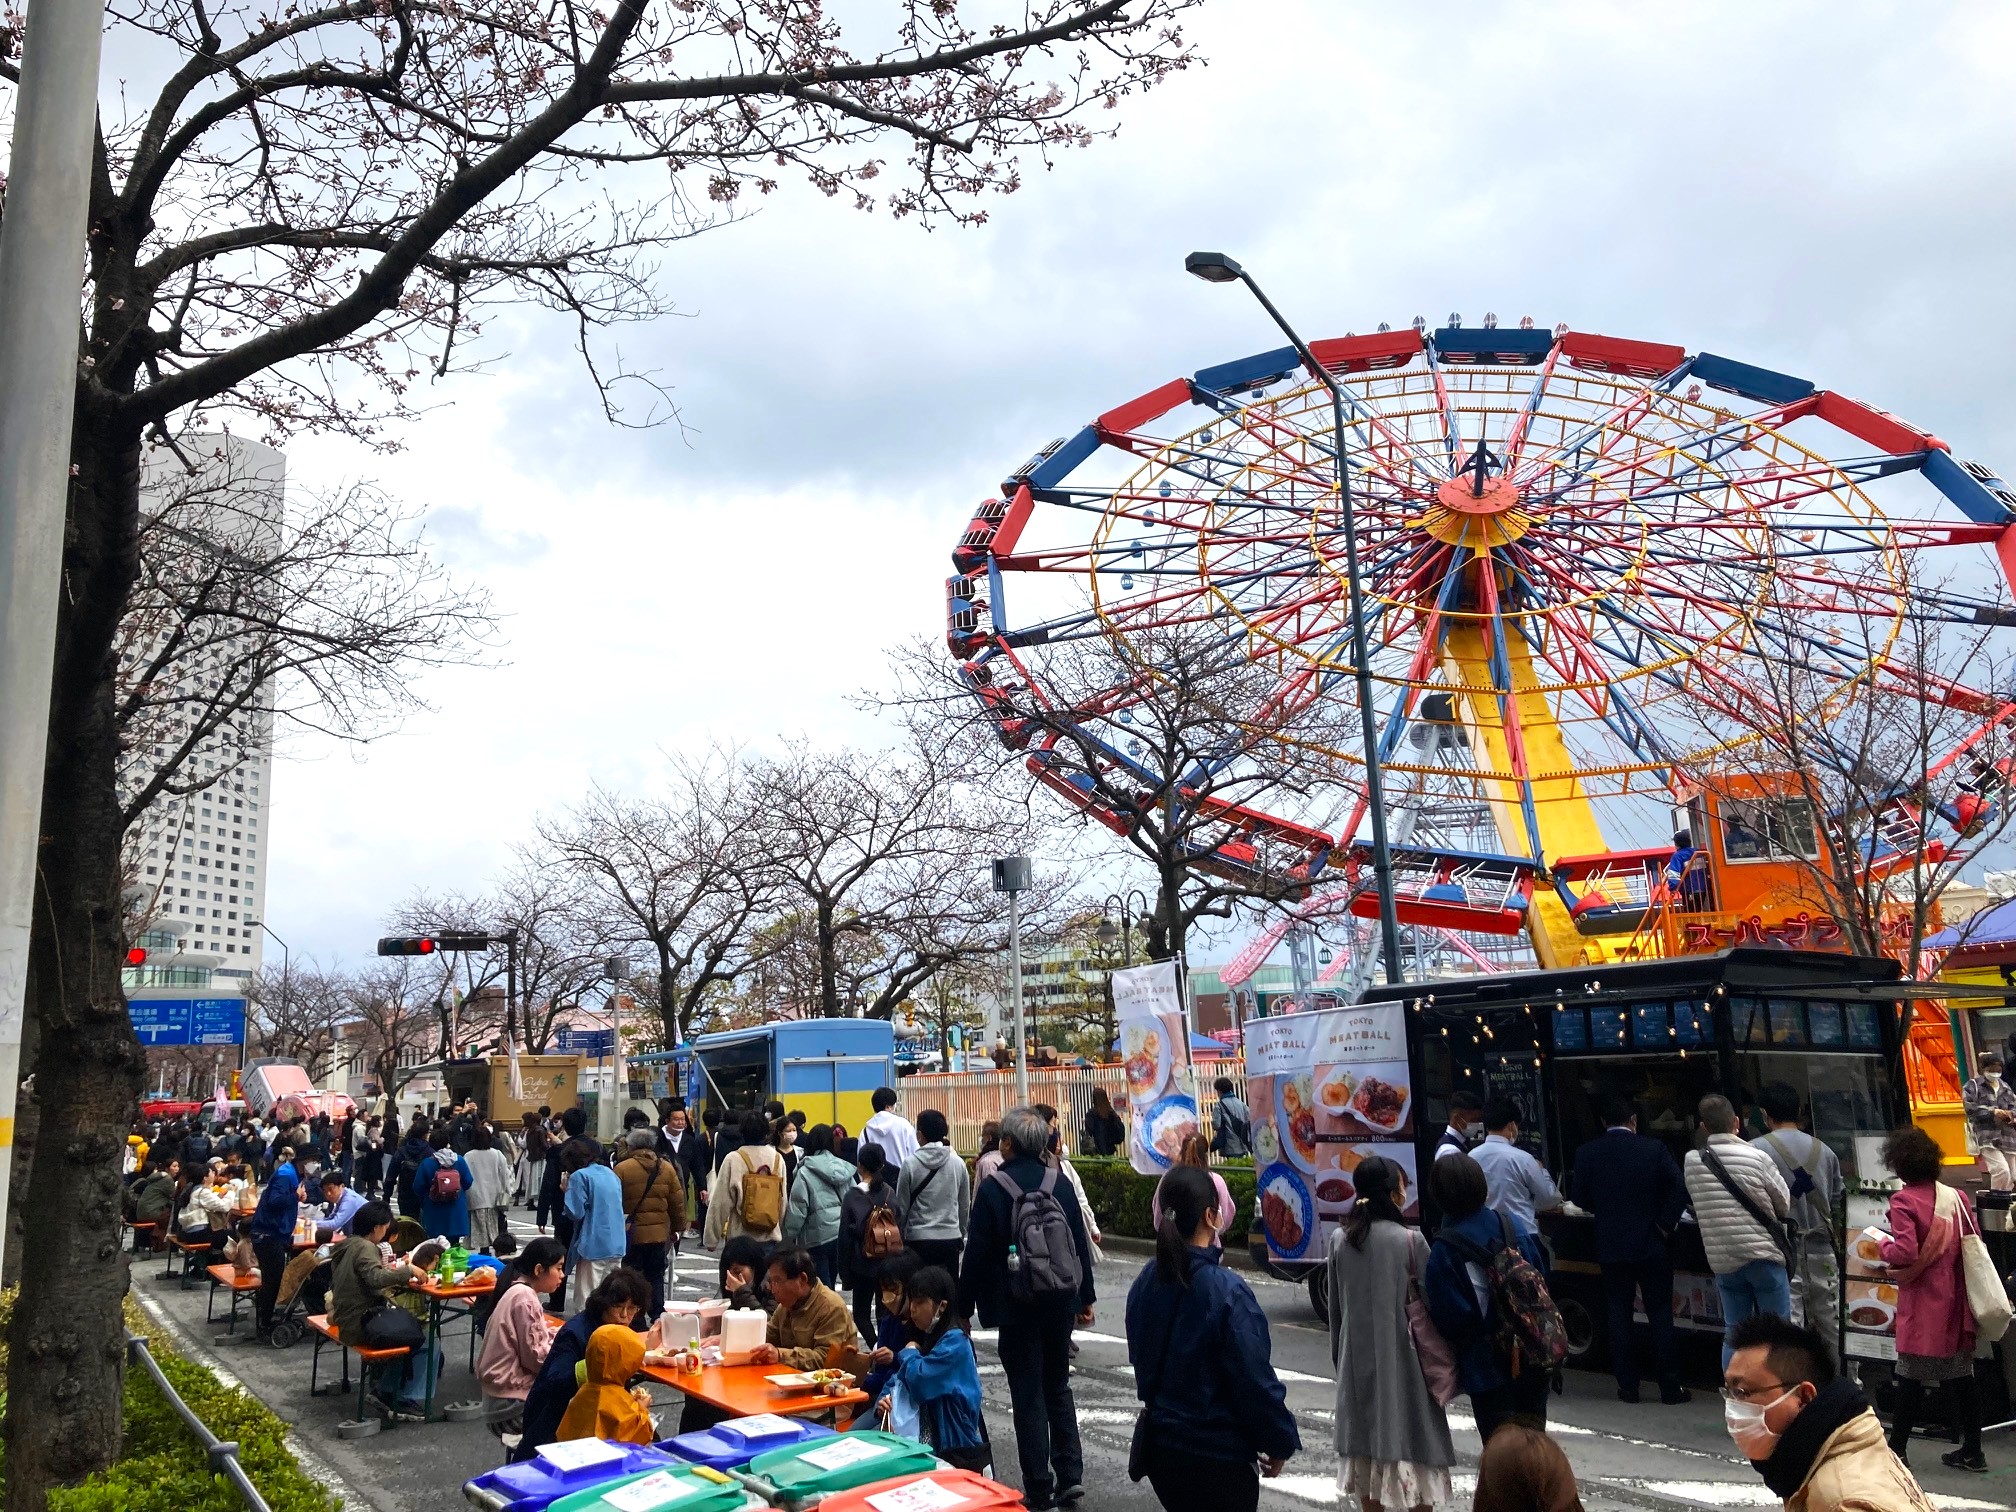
[1722, 1312, 1931, 1512]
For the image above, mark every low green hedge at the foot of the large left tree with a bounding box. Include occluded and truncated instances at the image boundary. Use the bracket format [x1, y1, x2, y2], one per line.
[0, 1294, 343, 1512]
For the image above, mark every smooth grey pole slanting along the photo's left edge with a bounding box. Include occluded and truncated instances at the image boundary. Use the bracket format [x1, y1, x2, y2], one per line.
[0, 0, 105, 1257]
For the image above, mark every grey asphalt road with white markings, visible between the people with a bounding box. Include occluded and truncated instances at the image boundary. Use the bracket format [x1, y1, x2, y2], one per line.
[135, 1212, 2016, 1512]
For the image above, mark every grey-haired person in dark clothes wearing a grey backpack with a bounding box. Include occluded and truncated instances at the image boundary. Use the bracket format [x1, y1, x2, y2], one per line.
[960, 1107, 1096, 1512]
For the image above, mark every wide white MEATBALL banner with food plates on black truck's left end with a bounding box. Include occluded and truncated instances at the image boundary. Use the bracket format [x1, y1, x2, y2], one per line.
[1246, 1004, 1421, 1260]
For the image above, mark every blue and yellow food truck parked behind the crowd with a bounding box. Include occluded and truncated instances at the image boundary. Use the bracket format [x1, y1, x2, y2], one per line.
[627, 1018, 895, 1131]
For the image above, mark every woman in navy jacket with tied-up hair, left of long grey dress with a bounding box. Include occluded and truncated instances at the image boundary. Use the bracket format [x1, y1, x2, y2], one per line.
[1128, 1161, 1298, 1512]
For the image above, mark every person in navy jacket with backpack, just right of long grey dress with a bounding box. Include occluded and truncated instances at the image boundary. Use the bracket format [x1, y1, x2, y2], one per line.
[1421, 1155, 1566, 1443]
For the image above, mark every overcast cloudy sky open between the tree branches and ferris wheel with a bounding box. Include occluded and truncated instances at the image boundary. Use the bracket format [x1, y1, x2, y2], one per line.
[268, 0, 2016, 960]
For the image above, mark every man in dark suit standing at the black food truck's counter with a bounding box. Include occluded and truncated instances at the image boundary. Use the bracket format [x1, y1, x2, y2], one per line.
[1572, 1099, 1691, 1403]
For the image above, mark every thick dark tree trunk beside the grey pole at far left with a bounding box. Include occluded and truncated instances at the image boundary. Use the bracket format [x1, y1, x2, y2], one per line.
[4, 421, 147, 1512]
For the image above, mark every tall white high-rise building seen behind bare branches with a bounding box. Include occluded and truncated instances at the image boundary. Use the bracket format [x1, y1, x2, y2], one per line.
[121, 435, 286, 996]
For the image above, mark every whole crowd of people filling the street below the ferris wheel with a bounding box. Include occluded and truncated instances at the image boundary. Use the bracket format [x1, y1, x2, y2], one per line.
[125, 1060, 2016, 1512]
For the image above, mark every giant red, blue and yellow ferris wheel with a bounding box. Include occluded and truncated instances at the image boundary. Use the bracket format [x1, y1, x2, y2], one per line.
[948, 317, 2016, 964]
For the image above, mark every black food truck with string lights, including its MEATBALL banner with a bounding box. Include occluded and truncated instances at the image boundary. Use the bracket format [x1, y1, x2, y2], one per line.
[1246, 946, 1966, 1365]
